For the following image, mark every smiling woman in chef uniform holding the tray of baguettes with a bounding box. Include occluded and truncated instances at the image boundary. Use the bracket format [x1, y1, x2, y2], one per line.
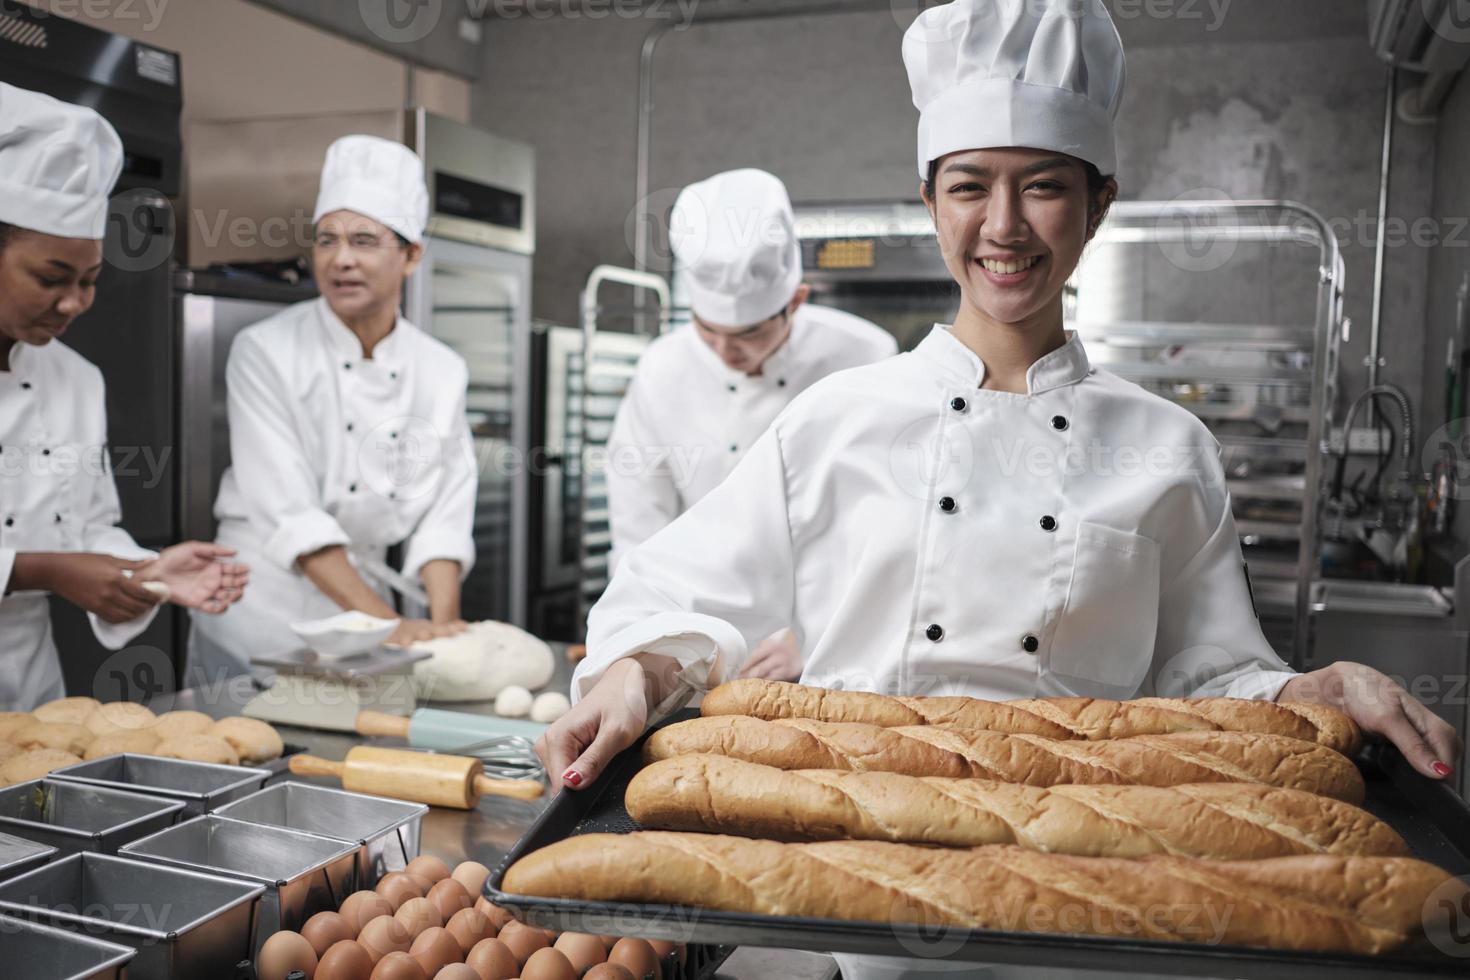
[538, 0, 1460, 977]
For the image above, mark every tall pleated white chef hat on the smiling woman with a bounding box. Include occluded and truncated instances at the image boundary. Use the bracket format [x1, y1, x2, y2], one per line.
[904, 0, 1126, 178]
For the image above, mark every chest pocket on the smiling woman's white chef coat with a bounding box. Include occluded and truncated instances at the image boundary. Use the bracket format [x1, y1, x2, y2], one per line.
[1047, 522, 1158, 698]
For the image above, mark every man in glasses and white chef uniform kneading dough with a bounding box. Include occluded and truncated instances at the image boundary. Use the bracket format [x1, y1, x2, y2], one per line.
[190, 135, 478, 677]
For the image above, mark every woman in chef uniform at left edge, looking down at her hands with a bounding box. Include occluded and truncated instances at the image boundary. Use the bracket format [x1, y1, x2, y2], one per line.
[0, 84, 248, 711]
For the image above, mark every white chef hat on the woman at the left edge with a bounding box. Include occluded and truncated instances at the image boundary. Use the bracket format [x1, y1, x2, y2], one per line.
[0, 82, 122, 239]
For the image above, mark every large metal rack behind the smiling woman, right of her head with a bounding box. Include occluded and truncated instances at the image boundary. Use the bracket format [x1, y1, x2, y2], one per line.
[1067, 201, 1344, 667]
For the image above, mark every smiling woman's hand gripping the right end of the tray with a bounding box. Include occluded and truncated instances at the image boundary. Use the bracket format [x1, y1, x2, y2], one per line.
[1276, 661, 1464, 779]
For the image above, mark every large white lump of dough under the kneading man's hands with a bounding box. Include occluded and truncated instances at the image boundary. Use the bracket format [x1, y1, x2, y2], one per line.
[413, 620, 556, 701]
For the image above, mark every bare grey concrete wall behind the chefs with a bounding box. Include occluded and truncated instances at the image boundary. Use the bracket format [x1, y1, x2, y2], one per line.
[472, 0, 1442, 429]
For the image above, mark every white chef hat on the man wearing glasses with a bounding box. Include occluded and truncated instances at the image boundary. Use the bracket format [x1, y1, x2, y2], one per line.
[312, 135, 429, 241]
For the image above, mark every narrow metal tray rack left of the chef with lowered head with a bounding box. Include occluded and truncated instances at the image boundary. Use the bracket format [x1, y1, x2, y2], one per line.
[566, 266, 672, 624]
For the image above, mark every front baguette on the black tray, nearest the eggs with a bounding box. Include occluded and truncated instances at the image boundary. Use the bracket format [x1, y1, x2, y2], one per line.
[503, 830, 1470, 954]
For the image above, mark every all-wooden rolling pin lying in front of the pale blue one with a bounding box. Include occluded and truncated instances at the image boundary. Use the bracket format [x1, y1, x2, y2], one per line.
[291, 745, 545, 810]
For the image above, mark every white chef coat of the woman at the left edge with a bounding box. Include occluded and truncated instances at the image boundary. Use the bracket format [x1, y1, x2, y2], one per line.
[0, 341, 157, 711]
